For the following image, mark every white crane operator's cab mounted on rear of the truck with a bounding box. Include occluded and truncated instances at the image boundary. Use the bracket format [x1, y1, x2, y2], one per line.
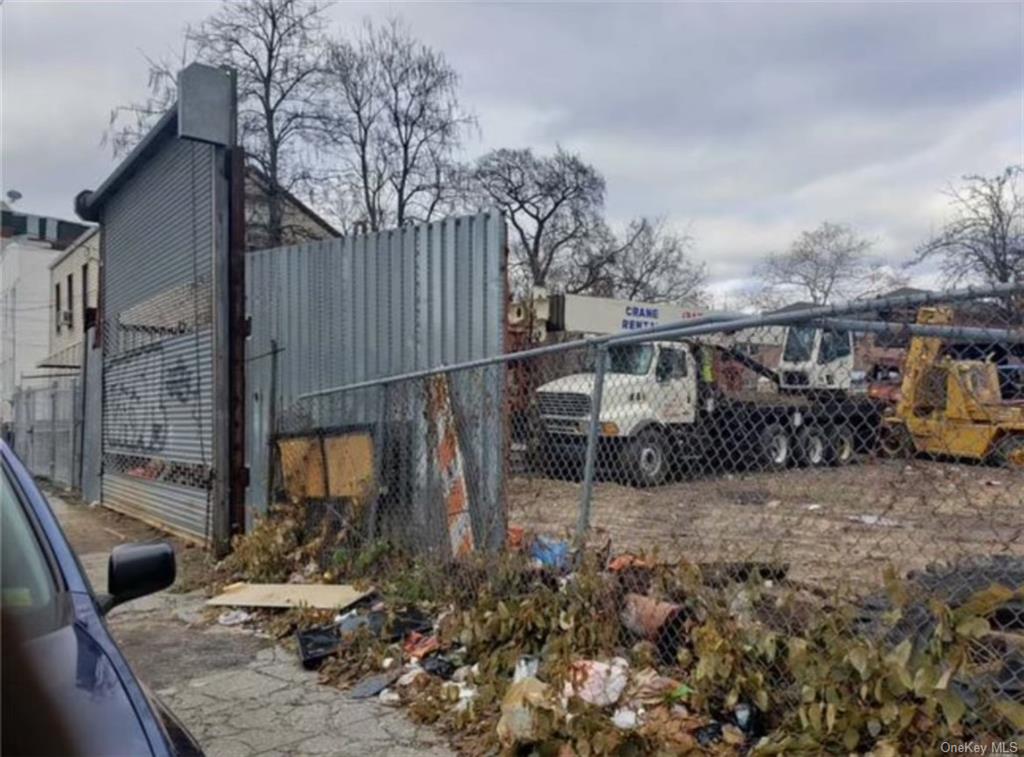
[778, 326, 854, 391]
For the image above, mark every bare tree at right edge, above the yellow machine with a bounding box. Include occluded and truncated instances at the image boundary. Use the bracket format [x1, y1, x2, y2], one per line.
[910, 166, 1024, 286]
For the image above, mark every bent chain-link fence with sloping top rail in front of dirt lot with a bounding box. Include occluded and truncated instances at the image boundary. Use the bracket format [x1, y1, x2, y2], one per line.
[268, 285, 1024, 751]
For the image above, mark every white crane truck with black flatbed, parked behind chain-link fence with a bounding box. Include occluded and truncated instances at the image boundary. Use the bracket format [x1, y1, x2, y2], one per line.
[520, 290, 880, 486]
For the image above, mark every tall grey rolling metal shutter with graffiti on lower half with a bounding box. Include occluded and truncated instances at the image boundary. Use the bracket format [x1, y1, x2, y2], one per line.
[102, 138, 217, 542]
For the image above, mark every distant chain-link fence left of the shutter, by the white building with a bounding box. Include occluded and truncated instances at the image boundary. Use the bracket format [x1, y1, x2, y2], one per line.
[11, 377, 83, 489]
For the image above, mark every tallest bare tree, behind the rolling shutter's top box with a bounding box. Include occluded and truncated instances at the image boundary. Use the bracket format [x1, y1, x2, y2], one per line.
[106, 0, 326, 245]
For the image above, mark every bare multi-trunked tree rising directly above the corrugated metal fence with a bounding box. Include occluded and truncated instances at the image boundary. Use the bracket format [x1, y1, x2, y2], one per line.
[321, 20, 475, 230]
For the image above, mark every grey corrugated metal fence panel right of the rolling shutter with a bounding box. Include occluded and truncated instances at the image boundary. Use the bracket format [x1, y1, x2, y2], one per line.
[246, 212, 506, 544]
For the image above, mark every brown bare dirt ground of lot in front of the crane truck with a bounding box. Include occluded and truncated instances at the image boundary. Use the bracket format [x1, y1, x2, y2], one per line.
[508, 461, 1024, 585]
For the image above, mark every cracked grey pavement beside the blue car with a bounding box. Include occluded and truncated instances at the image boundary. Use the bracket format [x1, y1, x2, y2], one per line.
[47, 494, 453, 757]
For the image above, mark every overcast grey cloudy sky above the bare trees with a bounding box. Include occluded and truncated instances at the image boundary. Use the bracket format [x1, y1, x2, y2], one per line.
[0, 0, 1024, 301]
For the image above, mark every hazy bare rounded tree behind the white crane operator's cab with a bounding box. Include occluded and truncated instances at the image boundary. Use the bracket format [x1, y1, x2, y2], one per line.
[755, 221, 879, 305]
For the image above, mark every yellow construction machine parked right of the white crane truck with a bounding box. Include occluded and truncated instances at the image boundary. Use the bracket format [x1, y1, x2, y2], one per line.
[881, 307, 1024, 468]
